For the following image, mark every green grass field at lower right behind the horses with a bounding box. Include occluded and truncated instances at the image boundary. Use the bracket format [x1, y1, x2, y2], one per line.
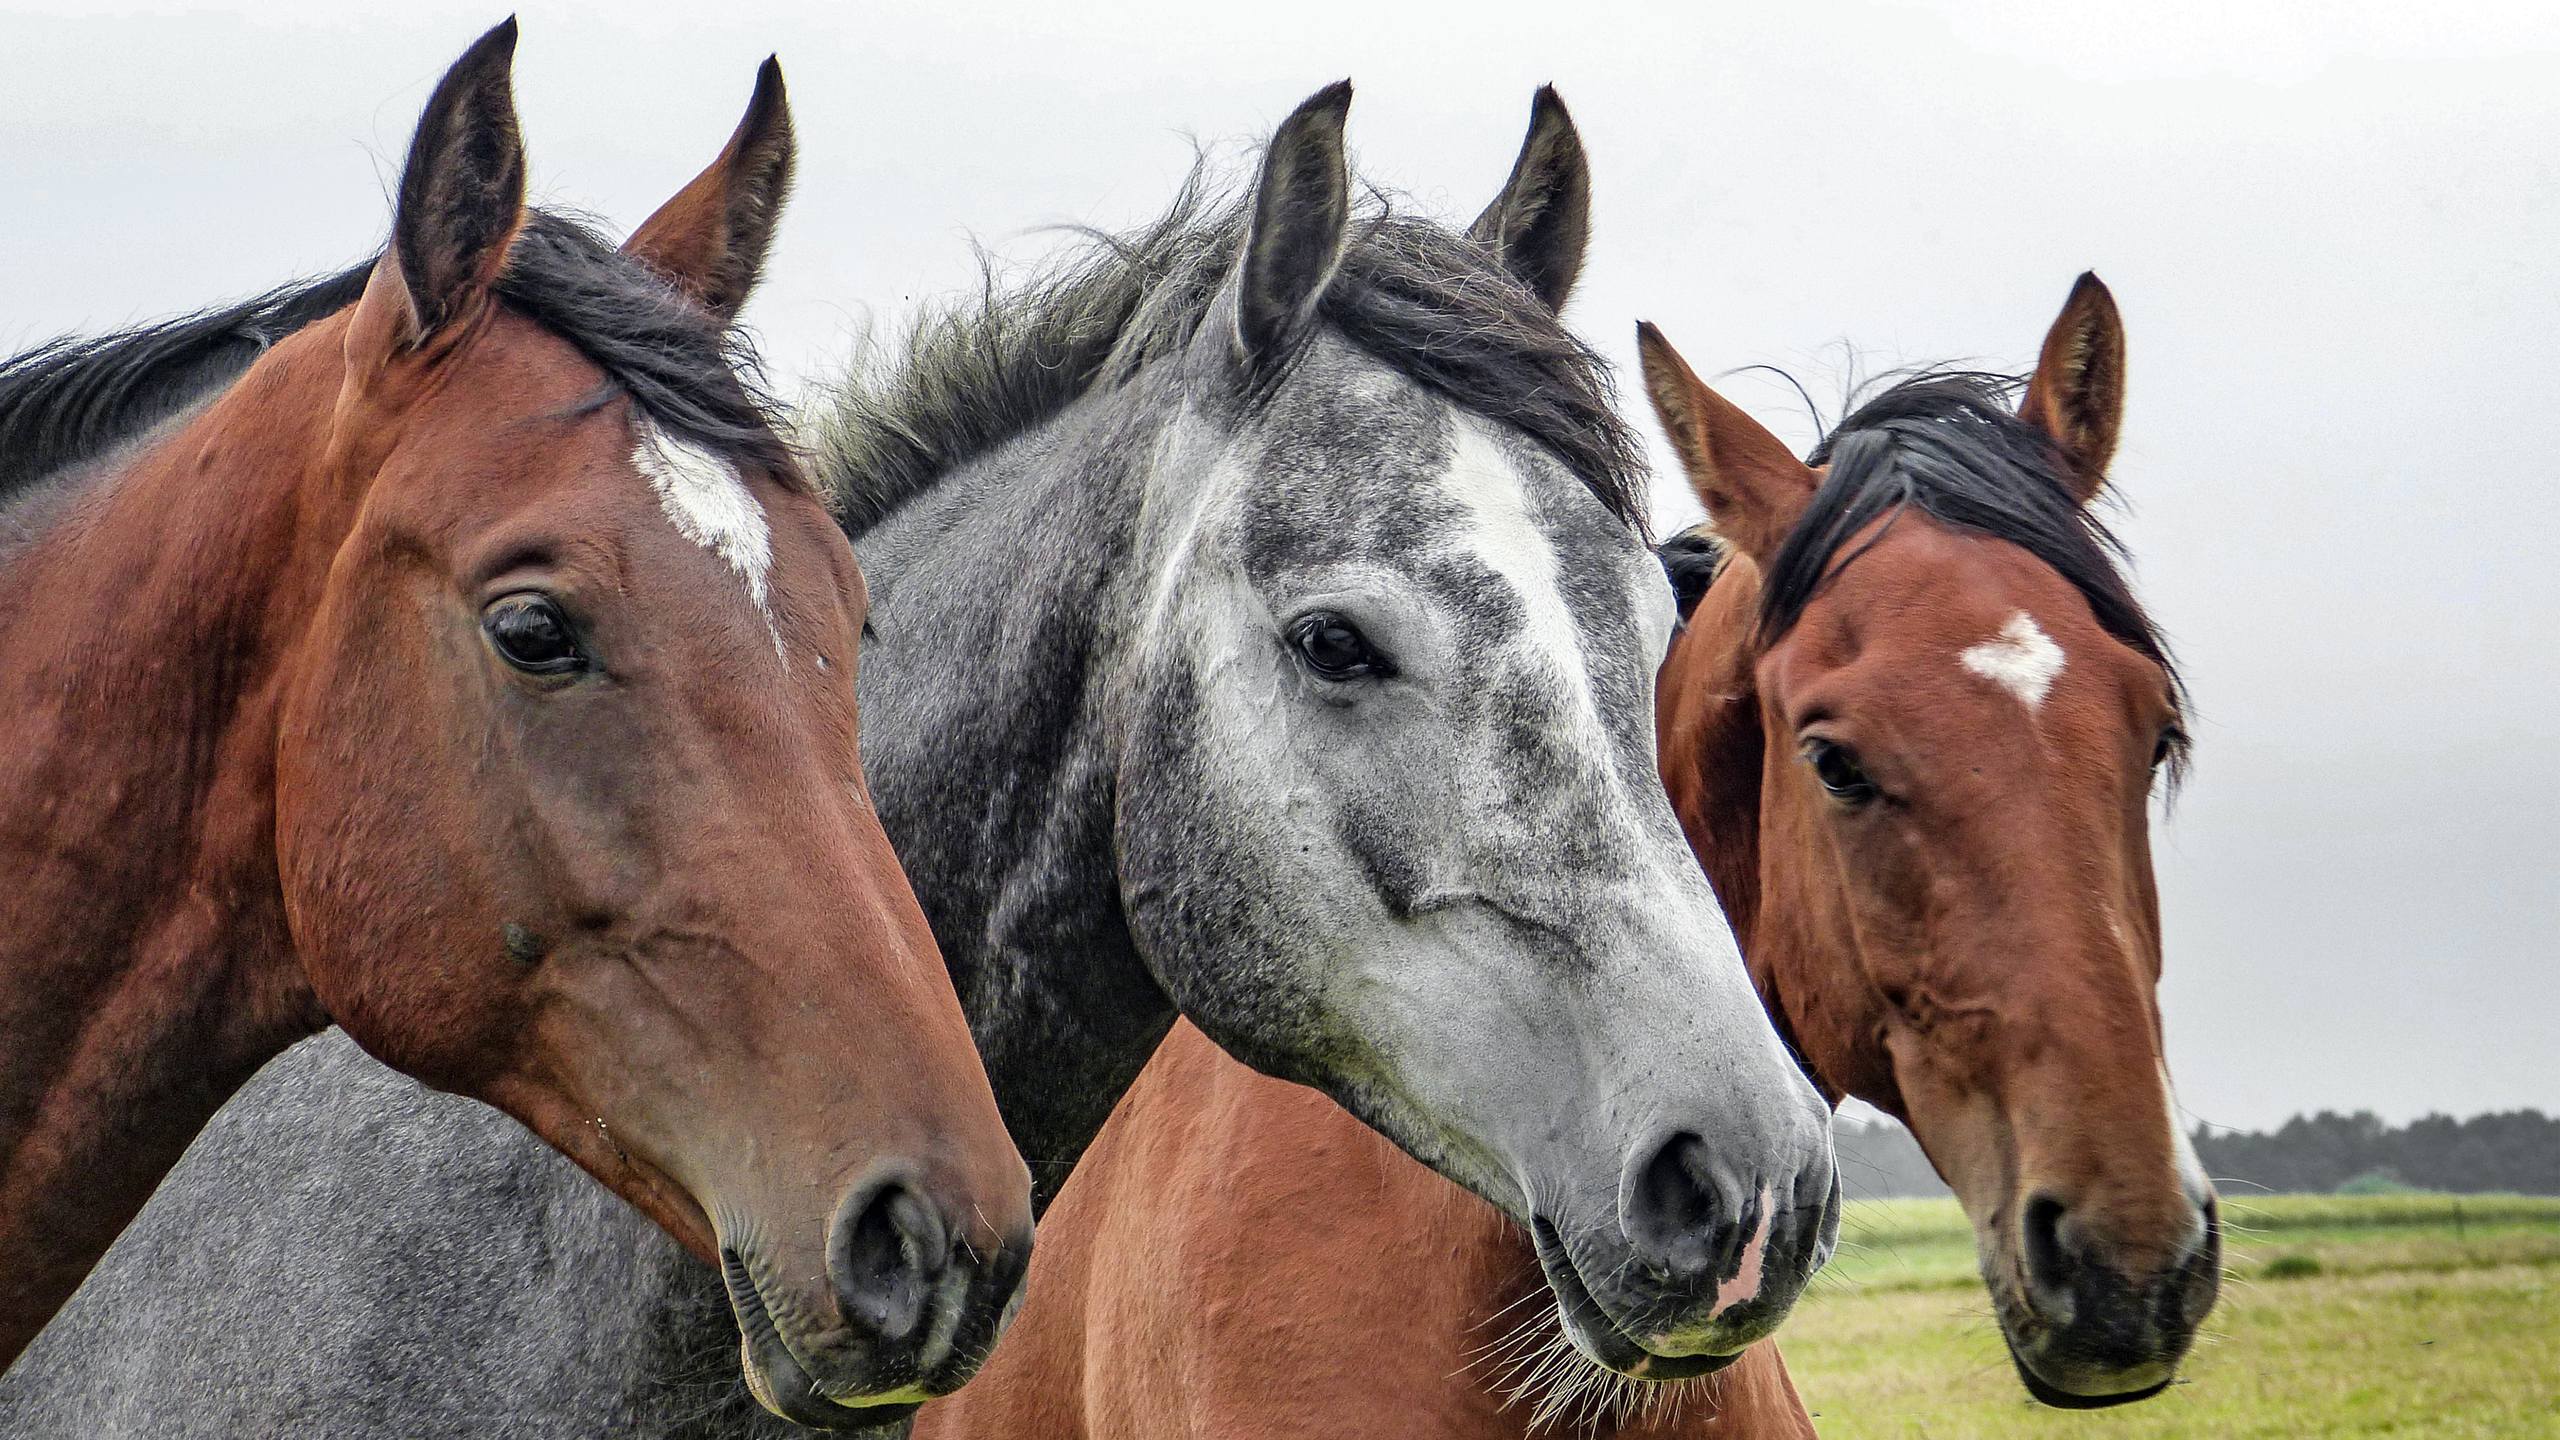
[1779, 1194, 2560, 1440]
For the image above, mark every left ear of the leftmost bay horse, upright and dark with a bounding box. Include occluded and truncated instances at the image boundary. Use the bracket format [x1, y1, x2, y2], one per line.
[392, 18, 525, 343]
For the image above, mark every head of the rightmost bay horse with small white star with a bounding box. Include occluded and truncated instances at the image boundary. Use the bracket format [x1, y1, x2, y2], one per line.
[1641, 277, 2222, 1407]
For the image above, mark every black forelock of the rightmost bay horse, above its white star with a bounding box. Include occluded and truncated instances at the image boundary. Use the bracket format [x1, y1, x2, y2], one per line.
[1761, 372, 2186, 763]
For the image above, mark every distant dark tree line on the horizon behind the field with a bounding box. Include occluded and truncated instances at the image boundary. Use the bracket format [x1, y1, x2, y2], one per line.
[1833, 1109, 2560, 1199]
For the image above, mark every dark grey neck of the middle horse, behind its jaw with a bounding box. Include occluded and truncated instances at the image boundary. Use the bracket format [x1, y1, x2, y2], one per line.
[855, 387, 1175, 1209]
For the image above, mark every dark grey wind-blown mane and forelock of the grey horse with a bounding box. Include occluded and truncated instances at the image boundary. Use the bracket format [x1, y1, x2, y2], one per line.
[809, 164, 1644, 533]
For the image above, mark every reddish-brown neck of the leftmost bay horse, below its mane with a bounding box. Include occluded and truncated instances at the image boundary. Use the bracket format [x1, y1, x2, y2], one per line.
[0, 311, 346, 1363]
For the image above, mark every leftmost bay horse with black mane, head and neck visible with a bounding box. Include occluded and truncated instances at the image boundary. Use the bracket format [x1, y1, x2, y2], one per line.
[0, 20, 1032, 1432]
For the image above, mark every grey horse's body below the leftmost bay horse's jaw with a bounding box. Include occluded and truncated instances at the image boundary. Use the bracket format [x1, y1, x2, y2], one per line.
[0, 1030, 757, 1440]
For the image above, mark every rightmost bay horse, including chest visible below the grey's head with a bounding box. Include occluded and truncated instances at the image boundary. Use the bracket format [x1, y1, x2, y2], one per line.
[916, 277, 2220, 1440]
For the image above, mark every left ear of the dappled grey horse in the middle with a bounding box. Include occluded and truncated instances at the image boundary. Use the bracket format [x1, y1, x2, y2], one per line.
[1236, 79, 1352, 369]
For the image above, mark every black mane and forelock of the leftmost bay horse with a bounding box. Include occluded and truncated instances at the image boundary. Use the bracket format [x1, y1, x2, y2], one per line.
[0, 210, 801, 505]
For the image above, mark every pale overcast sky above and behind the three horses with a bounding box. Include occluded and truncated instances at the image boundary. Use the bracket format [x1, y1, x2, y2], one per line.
[0, 0, 2560, 1125]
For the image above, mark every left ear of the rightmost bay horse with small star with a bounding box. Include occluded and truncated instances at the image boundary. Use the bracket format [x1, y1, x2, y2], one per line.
[1636, 323, 1820, 566]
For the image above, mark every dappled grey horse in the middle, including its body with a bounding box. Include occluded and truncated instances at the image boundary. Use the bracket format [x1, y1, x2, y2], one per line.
[0, 85, 1838, 1437]
